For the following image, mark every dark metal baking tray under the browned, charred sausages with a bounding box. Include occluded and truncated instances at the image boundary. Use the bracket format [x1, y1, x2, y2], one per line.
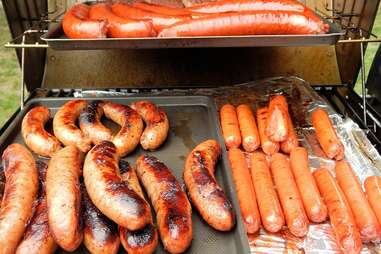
[0, 96, 250, 254]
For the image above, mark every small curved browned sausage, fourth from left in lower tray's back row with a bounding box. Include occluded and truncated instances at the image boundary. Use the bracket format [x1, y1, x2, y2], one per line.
[103, 102, 143, 157]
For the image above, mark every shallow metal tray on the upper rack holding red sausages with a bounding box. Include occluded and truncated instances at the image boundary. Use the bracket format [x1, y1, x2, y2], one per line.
[41, 19, 344, 50]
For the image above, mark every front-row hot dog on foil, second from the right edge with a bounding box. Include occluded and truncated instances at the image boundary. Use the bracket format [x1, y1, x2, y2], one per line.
[335, 161, 381, 242]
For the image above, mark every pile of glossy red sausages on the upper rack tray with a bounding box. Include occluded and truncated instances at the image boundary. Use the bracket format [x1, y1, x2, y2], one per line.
[62, 0, 329, 39]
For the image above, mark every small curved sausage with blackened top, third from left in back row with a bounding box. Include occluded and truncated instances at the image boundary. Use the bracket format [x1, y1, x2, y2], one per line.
[78, 101, 112, 145]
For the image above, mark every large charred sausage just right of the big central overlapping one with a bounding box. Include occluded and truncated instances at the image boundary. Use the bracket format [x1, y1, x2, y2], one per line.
[136, 155, 192, 253]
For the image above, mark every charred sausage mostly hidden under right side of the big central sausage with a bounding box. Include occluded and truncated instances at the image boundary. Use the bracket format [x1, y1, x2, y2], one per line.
[119, 161, 158, 254]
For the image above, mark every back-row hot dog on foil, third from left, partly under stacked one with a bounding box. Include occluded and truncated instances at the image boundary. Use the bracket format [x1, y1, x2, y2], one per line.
[257, 108, 279, 155]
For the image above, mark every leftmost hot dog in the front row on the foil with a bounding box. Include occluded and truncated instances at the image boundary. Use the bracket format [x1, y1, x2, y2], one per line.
[228, 148, 261, 234]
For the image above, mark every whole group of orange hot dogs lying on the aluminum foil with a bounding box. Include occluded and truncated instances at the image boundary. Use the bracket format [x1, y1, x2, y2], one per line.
[220, 95, 381, 253]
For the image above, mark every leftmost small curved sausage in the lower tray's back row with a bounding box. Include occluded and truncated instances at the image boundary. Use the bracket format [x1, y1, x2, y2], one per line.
[21, 106, 61, 157]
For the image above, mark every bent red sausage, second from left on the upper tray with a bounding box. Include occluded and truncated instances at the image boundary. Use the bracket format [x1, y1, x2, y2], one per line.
[89, 3, 156, 38]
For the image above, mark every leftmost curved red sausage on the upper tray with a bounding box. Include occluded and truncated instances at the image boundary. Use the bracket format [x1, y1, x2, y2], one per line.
[62, 4, 107, 39]
